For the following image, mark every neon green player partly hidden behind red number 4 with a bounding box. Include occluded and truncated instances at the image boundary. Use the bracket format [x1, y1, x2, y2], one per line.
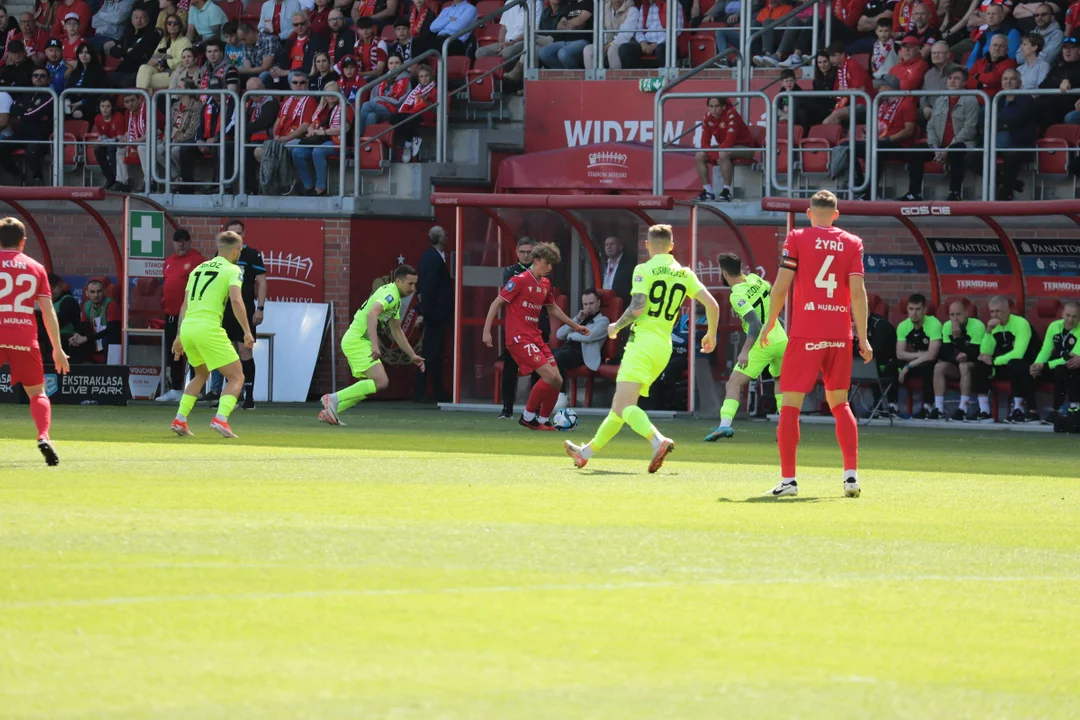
[705, 253, 787, 443]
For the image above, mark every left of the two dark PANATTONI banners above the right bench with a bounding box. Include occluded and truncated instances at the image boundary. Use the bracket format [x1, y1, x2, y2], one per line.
[927, 237, 1017, 295]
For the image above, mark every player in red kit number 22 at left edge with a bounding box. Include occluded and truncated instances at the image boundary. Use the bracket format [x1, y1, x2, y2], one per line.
[0, 217, 70, 465]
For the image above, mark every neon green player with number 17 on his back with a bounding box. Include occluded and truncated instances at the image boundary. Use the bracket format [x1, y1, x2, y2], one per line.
[172, 232, 255, 437]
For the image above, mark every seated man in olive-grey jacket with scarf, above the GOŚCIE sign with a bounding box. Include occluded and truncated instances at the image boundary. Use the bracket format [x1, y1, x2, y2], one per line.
[900, 65, 980, 202]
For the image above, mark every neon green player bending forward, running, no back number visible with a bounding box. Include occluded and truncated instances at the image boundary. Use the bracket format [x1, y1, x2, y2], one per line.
[319, 264, 423, 425]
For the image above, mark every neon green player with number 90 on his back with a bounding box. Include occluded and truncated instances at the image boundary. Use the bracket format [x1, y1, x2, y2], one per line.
[566, 225, 720, 473]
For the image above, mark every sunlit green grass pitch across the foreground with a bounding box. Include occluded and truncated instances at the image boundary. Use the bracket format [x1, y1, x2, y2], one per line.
[0, 404, 1080, 720]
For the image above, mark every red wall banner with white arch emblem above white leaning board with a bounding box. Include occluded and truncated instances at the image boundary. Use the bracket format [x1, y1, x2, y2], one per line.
[235, 218, 325, 302]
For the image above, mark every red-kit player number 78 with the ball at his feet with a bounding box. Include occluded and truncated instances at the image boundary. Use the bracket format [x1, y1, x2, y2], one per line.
[484, 243, 589, 430]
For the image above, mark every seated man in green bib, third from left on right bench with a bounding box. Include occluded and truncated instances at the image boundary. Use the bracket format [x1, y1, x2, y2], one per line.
[975, 296, 1039, 422]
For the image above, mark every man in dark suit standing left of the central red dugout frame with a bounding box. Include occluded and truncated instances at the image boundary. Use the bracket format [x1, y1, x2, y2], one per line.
[413, 225, 454, 403]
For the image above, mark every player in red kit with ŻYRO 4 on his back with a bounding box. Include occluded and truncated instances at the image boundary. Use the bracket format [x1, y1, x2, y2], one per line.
[761, 190, 874, 498]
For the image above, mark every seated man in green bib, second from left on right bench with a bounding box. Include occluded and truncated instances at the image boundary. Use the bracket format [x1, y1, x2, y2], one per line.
[930, 300, 990, 422]
